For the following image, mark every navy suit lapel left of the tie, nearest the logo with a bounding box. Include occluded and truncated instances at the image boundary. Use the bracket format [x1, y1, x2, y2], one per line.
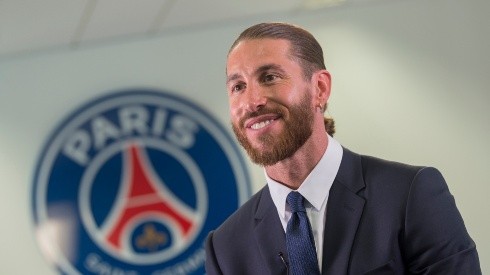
[255, 186, 288, 274]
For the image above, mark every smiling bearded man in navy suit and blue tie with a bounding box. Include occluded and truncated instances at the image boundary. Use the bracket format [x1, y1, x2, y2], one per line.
[206, 23, 481, 275]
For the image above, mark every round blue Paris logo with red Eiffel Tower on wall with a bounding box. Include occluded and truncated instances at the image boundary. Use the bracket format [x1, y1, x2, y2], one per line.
[32, 90, 250, 275]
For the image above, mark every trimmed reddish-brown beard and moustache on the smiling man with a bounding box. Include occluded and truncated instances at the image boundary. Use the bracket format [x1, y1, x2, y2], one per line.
[232, 90, 313, 166]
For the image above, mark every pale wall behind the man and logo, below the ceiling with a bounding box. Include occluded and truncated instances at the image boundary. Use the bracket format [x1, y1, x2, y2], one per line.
[0, 0, 490, 274]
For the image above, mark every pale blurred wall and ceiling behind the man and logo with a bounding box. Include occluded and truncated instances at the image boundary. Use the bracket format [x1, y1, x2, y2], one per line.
[0, 0, 490, 274]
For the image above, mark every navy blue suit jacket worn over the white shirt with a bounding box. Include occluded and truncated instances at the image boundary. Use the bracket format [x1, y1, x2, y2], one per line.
[206, 149, 481, 275]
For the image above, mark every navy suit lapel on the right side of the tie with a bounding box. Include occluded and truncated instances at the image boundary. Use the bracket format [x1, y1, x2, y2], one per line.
[322, 148, 364, 275]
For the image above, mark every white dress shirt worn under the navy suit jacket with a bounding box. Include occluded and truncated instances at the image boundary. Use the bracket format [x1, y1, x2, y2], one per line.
[265, 135, 343, 271]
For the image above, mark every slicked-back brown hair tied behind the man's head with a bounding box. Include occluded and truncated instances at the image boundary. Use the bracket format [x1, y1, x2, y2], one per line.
[228, 22, 335, 136]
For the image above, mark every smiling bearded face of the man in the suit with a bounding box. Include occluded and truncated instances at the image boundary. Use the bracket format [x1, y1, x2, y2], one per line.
[226, 39, 315, 166]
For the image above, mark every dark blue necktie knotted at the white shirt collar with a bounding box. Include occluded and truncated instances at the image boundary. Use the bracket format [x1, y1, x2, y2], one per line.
[286, 191, 320, 275]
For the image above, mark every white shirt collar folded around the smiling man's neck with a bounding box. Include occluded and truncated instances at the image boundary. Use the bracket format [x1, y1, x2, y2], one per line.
[264, 135, 343, 218]
